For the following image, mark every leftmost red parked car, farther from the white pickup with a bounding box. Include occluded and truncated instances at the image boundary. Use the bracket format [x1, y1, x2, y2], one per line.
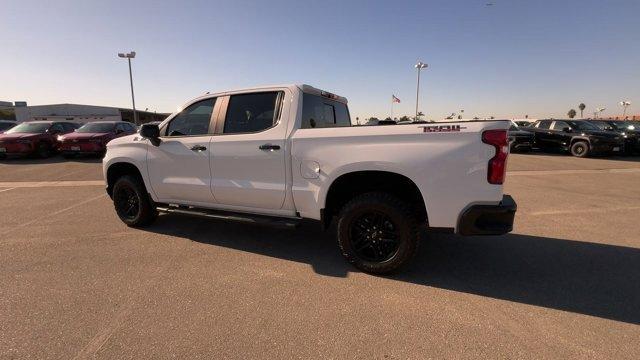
[0, 121, 78, 158]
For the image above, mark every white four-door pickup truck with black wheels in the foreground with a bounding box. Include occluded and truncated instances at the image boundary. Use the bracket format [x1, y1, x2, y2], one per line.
[103, 85, 516, 273]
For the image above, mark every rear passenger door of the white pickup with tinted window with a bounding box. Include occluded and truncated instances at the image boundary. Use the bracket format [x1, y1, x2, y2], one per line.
[211, 91, 288, 210]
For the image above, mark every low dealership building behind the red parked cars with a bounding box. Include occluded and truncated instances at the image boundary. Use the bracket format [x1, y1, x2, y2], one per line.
[2, 101, 169, 124]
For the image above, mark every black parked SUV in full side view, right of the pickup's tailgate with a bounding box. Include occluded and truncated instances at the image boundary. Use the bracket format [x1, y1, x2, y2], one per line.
[524, 119, 624, 157]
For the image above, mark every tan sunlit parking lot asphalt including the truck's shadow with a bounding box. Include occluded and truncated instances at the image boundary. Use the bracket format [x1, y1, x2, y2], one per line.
[0, 154, 640, 359]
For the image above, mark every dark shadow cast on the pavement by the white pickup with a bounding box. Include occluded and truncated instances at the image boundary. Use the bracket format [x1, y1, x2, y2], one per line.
[147, 215, 640, 324]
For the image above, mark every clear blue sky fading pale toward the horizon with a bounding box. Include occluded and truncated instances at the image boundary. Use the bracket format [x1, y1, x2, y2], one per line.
[0, 0, 640, 119]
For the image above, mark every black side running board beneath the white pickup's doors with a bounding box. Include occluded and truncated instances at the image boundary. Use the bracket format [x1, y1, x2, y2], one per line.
[156, 204, 302, 228]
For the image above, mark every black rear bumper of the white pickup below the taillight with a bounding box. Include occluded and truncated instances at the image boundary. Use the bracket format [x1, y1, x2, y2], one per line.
[457, 195, 518, 235]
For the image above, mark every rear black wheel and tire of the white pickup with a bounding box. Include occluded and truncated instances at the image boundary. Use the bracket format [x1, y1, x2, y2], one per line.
[338, 193, 419, 274]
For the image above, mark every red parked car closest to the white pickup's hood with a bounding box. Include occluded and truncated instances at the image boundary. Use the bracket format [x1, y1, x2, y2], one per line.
[58, 121, 137, 158]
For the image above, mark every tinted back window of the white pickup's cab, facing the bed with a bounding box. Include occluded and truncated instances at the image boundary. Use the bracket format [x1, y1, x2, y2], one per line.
[301, 94, 351, 129]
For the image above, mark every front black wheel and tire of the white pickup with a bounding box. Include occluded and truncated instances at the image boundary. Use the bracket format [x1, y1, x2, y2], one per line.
[113, 175, 158, 227]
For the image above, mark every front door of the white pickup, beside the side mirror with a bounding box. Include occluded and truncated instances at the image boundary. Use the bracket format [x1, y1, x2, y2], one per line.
[147, 98, 219, 204]
